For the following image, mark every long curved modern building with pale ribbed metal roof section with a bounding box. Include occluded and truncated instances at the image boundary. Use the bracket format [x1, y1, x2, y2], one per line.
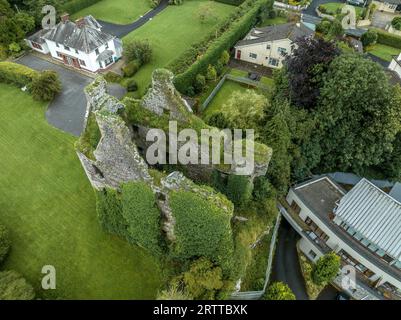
[279, 176, 401, 300]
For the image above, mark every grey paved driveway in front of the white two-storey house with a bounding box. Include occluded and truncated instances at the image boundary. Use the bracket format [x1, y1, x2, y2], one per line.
[16, 55, 126, 136]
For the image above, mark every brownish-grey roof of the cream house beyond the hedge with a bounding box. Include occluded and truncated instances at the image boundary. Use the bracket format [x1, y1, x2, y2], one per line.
[236, 23, 313, 47]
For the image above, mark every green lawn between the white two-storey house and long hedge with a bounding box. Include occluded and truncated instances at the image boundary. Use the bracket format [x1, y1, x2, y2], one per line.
[123, 0, 236, 95]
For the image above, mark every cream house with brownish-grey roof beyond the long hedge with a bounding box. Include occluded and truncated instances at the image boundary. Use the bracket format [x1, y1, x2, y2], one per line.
[235, 23, 313, 68]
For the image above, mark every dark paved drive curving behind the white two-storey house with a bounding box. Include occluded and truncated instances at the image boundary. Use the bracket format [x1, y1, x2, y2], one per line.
[98, 0, 169, 38]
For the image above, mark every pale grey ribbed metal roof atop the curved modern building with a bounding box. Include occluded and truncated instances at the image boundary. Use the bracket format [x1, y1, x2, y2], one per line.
[335, 179, 401, 259]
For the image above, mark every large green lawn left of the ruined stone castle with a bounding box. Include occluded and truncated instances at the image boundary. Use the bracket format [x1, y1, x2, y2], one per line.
[0, 84, 161, 299]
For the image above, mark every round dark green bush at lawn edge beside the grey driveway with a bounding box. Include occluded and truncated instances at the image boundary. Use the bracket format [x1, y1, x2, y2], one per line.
[30, 70, 61, 101]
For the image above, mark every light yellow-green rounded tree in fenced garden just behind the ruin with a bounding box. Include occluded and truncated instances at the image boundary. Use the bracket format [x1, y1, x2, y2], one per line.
[221, 90, 269, 131]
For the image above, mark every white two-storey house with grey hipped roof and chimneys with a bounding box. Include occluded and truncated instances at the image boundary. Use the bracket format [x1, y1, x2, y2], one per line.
[26, 14, 122, 72]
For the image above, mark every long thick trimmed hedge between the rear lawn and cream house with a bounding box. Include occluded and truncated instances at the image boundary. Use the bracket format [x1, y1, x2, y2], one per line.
[174, 1, 265, 93]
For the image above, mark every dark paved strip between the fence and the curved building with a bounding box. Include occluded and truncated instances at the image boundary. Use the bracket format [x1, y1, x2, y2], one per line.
[271, 219, 309, 300]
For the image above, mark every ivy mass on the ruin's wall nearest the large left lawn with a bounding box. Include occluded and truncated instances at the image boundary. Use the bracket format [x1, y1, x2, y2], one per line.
[97, 182, 161, 253]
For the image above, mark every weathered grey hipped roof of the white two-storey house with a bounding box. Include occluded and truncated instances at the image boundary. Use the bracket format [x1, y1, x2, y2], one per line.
[43, 16, 114, 53]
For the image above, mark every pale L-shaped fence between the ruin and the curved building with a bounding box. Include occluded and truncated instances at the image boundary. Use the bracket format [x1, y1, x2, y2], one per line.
[231, 213, 281, 300]
